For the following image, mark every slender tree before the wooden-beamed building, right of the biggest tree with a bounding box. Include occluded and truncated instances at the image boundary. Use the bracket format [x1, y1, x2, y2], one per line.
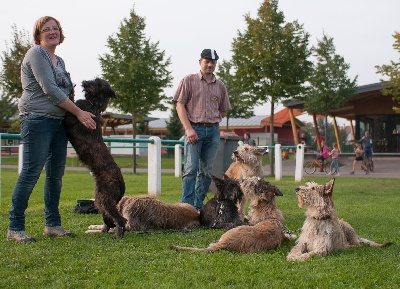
[304, 33, 357, 139]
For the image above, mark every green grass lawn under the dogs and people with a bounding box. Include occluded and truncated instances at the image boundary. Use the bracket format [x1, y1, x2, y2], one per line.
[0, 169, 400, 289]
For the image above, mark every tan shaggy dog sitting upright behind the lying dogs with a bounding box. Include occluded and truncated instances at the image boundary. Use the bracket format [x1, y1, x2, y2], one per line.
[225, 144, 266, 221]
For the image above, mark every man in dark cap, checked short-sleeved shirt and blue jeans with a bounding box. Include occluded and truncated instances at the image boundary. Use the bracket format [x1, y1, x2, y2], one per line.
[173, 49, 231, 210]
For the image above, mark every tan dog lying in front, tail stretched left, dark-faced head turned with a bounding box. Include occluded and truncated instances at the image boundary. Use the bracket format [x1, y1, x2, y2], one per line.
[170, 177, 288, 253]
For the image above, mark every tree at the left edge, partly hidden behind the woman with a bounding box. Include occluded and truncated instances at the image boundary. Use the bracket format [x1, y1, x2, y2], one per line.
[0, 24, 31, 132]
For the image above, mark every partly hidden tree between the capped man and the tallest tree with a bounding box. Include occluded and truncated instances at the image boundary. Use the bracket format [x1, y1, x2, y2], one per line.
[216, 60, 255, 129]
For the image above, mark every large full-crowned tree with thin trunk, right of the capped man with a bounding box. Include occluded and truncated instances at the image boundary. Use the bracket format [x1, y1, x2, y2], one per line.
[228, 0, 312, 175]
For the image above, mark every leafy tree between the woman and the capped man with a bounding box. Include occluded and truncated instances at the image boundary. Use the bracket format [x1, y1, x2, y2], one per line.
[99, 9, 172, 173]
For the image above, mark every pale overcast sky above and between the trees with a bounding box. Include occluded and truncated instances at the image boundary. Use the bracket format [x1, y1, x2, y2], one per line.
[0, 0, 400, 124]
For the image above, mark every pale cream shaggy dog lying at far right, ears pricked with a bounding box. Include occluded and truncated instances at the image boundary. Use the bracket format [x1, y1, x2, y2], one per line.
[287, 179, 390, 261]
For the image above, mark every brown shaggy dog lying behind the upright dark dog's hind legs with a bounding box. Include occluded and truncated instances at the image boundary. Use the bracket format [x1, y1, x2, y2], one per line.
[86, 196, 200, 234]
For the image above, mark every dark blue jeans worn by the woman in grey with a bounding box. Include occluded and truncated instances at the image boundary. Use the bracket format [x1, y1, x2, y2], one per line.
[8, 115, 68, 231]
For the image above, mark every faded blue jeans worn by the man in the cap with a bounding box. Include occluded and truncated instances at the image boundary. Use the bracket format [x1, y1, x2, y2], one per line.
[181, 126, 220, 210]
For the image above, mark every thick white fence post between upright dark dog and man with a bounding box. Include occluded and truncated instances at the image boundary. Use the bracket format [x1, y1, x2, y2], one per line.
[147, 136, 161, 196]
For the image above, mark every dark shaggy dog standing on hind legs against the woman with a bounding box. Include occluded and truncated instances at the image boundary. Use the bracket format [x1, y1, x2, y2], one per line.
[65, 78, 126, 238]
